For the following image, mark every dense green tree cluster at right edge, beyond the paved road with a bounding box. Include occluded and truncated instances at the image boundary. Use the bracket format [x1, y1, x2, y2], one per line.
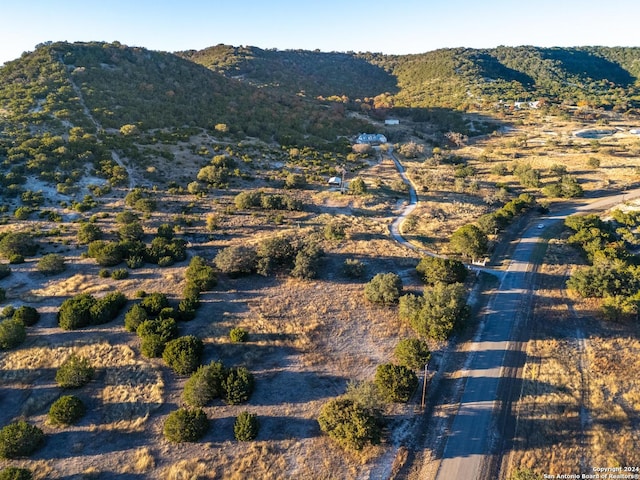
[565, 211, 640, 320]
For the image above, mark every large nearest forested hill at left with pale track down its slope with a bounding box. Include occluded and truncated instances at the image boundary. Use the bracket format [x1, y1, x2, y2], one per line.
[0, 42, 368, 142]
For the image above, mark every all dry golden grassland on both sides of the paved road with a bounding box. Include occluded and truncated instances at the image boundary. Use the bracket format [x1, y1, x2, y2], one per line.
[0, 107, 640, 480]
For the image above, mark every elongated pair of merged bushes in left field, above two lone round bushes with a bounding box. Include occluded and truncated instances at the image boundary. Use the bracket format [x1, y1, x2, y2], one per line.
[58, 292, 127, 330]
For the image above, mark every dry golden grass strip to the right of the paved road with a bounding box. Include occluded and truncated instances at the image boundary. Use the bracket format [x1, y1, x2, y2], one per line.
[505, 232, 640, 478]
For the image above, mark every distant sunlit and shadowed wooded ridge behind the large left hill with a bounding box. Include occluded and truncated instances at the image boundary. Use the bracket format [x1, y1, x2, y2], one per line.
[178, 45, 640, 108]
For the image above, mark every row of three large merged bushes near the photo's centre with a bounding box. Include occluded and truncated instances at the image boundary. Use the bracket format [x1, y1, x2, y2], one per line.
[214, 235, 324, 279]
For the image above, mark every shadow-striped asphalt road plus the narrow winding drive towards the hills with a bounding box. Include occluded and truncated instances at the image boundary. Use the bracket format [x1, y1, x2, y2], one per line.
[389, 151, 640, 480]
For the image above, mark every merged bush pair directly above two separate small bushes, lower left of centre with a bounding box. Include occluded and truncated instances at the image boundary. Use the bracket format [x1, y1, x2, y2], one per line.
[182, 362, 255, 407]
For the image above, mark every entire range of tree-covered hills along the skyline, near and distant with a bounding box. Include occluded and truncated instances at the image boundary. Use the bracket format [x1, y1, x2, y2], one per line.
[0, 42, 640, 144]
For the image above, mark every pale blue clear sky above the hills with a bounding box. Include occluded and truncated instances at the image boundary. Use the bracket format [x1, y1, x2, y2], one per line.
[0, 0, 640, 65]
